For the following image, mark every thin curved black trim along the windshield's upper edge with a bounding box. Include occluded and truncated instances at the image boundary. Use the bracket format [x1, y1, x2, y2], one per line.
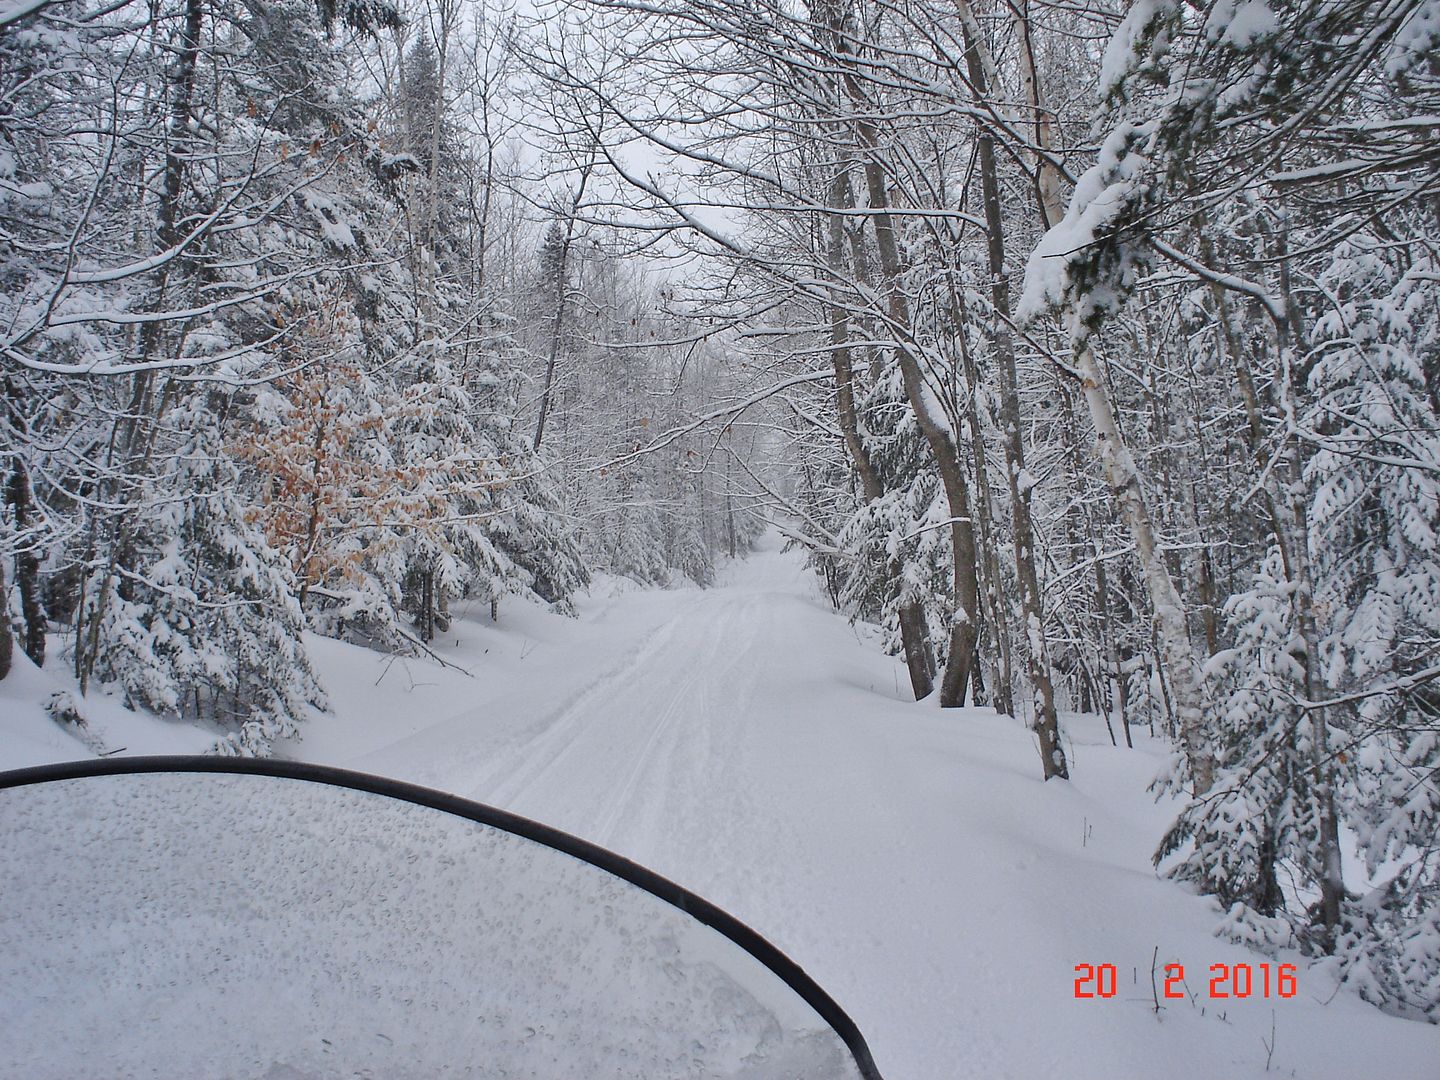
[0, 755, 881, 1080]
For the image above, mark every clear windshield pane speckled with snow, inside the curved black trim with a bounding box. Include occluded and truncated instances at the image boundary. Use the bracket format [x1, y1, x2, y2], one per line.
[0, 773, 858, 1080]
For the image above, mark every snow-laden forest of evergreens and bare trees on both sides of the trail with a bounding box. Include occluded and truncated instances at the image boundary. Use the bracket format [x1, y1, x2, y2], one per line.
[0, 0, 1440, 1054]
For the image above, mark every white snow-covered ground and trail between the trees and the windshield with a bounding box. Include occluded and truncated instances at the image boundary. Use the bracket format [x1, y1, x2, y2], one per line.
[0, 543, 1440, 1080]
